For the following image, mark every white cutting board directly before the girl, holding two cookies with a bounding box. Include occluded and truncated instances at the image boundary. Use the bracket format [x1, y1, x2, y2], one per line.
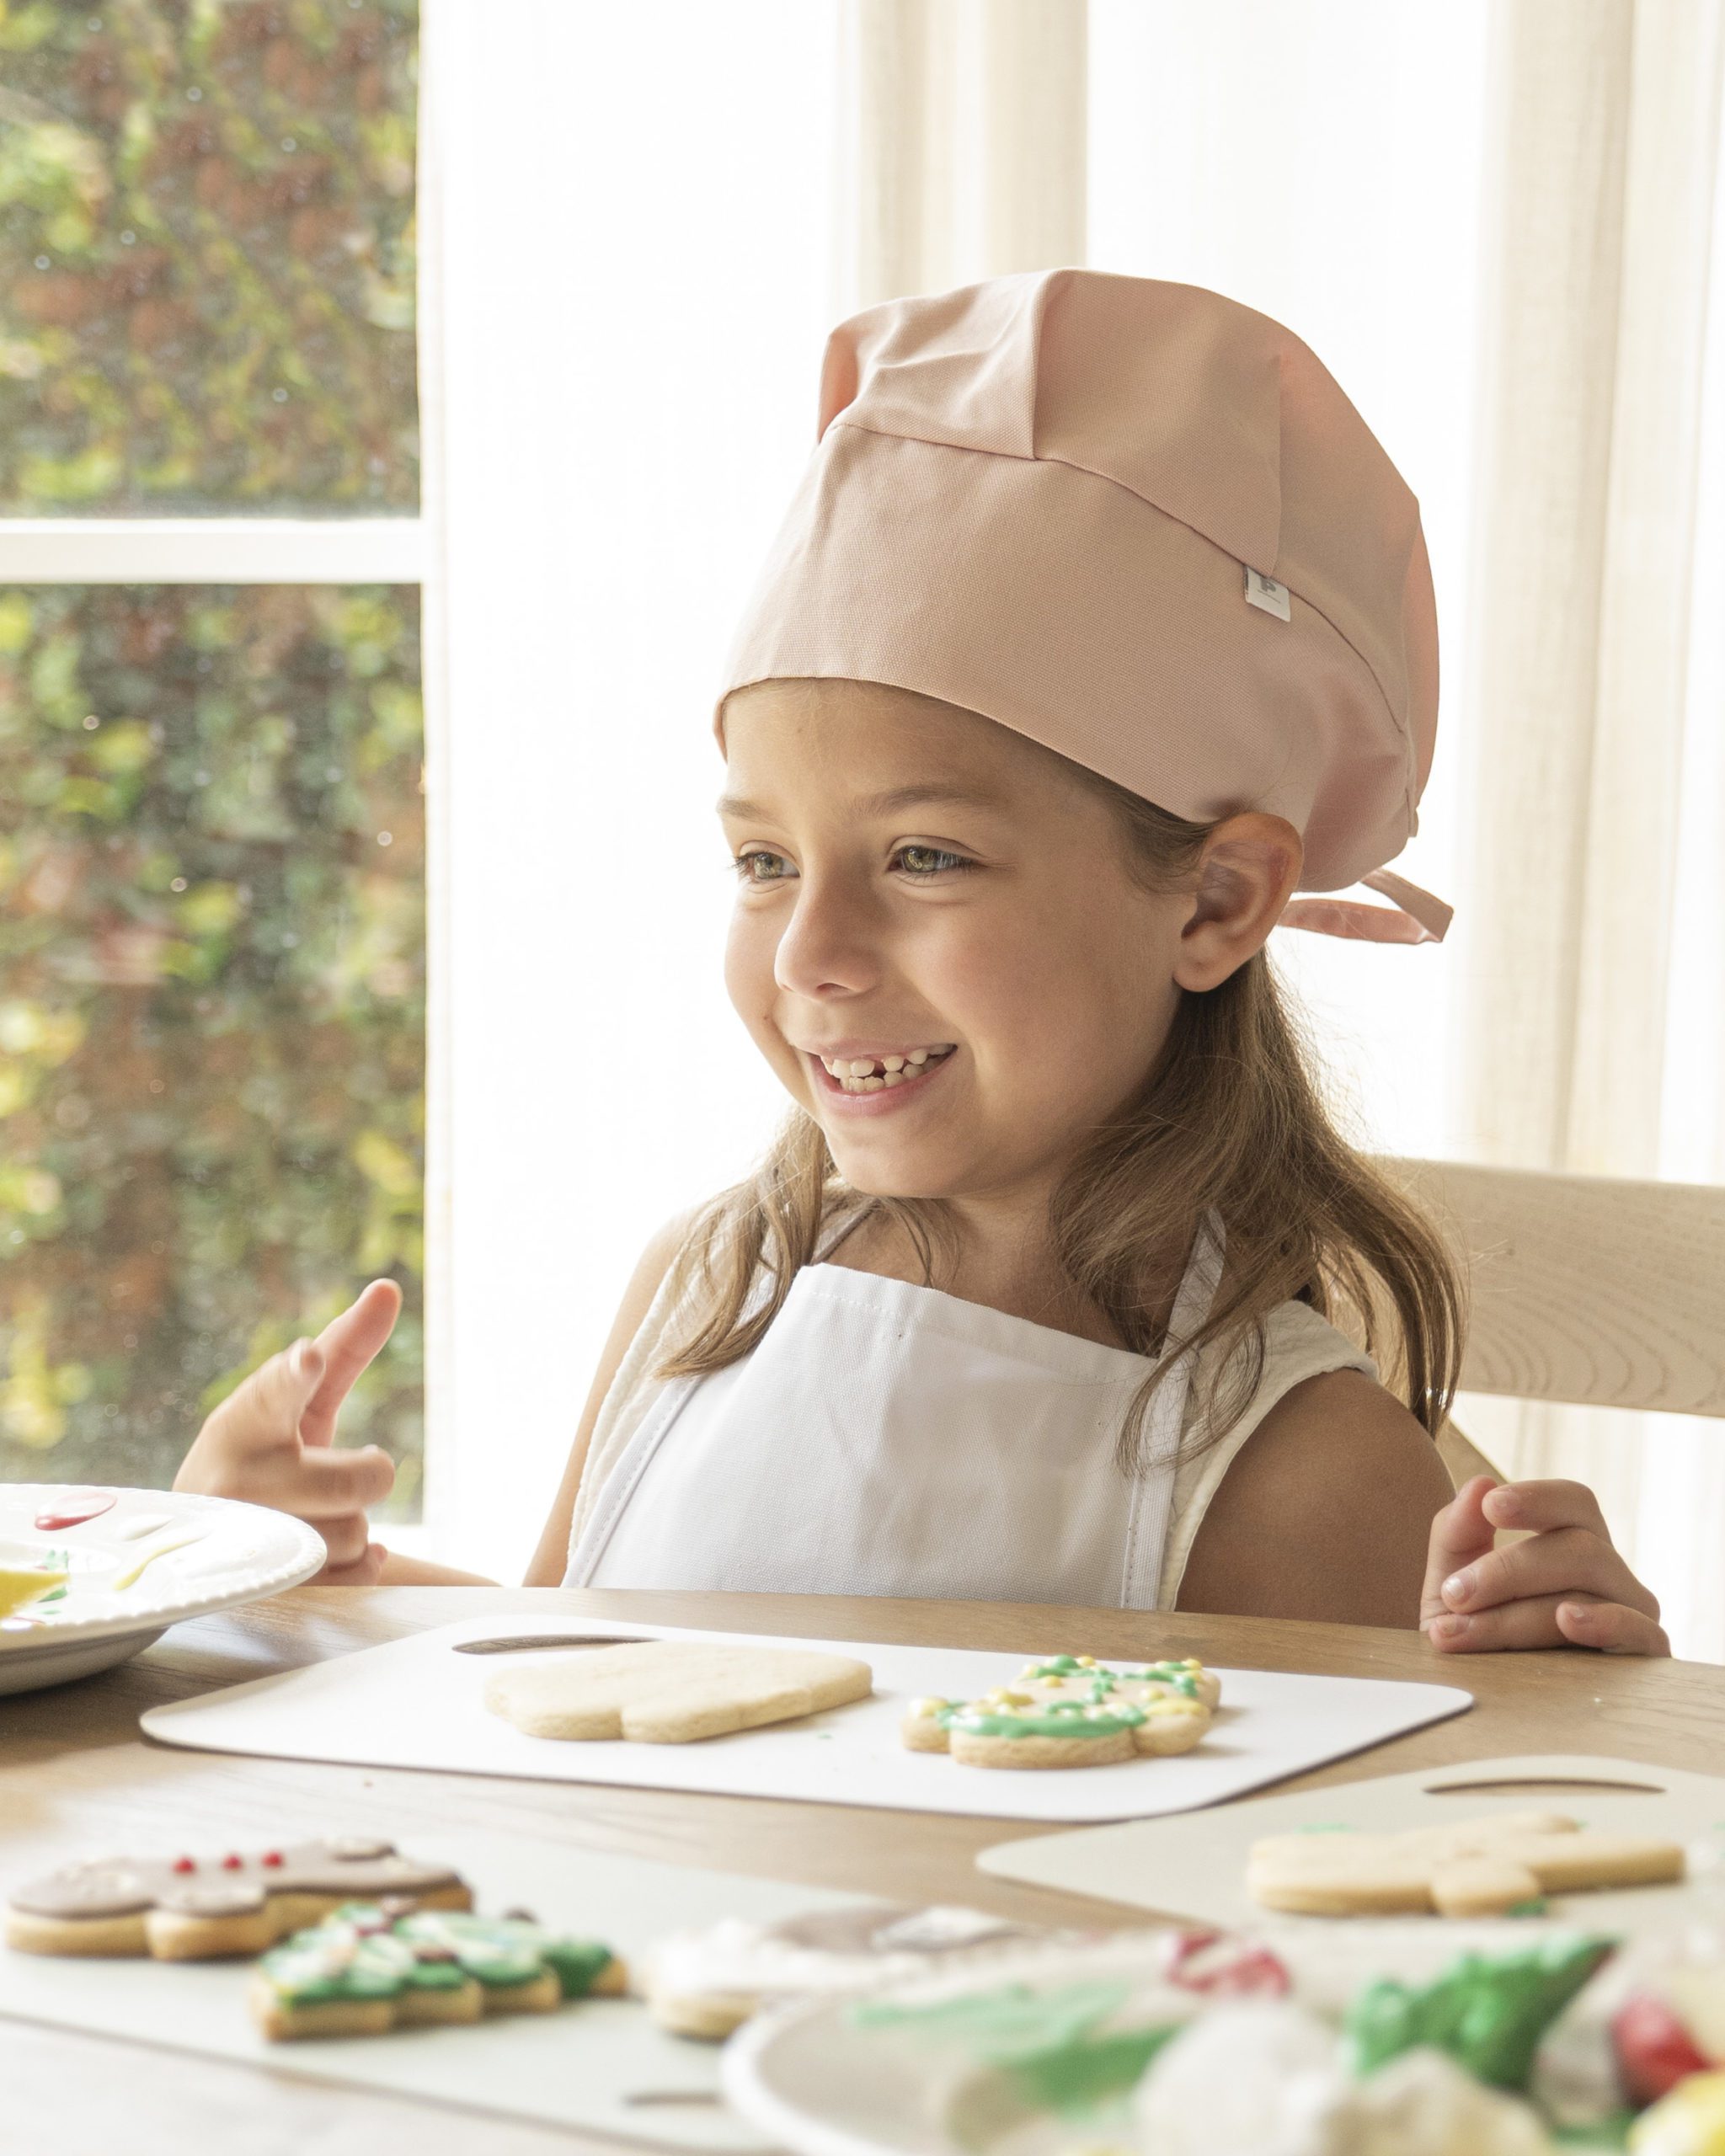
[142, 1617, 1472, 1820]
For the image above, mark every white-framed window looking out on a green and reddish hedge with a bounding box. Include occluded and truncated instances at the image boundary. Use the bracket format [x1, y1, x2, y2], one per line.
[0, 0, 425, 1518]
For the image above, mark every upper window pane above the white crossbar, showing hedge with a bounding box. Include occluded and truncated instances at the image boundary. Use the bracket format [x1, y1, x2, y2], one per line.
[0, 0, 419, 515]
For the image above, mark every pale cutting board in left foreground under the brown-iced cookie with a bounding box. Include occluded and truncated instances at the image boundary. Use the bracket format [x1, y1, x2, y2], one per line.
[0, 1828, 888, 2156]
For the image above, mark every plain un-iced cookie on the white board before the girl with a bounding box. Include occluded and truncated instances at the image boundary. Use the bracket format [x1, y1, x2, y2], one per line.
[485, 1639, 873, 1744]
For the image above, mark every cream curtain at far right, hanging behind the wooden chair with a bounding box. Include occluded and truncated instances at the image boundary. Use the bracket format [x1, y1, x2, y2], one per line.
[1453, 0, 1725, 1660]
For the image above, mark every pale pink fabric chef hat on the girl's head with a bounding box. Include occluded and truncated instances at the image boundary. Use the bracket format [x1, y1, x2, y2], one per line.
[713, 270, 1449, 942]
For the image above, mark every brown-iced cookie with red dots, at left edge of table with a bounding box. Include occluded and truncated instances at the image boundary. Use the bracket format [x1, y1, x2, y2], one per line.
[7, 1837, 473, 1962]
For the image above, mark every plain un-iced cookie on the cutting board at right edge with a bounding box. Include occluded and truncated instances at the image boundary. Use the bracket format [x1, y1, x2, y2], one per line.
[1247, 1811, 1684, 1917]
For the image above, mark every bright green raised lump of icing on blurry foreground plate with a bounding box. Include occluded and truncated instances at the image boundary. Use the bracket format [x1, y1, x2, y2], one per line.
[1343, 1936, 1615, 2089]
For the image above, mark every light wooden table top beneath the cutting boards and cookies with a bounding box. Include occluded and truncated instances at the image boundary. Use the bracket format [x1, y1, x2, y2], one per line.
[0, 1587, 1725, 2156]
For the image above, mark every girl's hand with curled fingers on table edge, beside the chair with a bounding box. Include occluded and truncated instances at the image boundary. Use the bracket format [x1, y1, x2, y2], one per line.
[1418, 1475, 1671, 1654]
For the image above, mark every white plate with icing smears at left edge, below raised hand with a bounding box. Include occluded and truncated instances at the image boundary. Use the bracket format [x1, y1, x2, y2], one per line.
[0, 1483, 326, 1693]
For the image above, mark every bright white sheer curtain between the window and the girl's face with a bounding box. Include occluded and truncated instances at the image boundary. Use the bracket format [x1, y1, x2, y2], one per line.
[420, 0, 836, 1580]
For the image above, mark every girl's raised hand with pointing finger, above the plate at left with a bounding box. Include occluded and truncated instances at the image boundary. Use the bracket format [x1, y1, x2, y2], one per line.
[174, 1281, 401, 1587]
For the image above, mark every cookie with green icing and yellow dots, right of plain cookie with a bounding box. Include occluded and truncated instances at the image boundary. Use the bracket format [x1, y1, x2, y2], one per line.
[901, 1654, 1223, 1768]
